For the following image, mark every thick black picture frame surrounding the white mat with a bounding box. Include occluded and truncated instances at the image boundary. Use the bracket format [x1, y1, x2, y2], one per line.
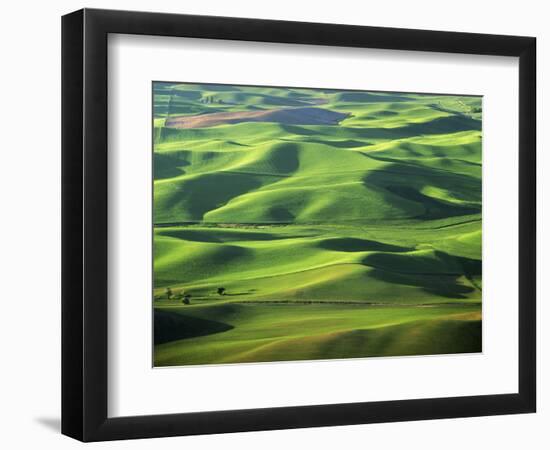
[62, 9, 536, 441]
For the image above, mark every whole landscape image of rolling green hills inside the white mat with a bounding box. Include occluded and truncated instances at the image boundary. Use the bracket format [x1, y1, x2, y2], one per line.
[153, 82, 482, 366]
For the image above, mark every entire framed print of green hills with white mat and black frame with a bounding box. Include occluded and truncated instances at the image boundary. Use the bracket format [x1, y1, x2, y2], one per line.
[62, 9, 536, 441]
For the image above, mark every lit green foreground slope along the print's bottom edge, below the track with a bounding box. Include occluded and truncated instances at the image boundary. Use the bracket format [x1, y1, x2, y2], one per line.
[155, 302, 481, 365]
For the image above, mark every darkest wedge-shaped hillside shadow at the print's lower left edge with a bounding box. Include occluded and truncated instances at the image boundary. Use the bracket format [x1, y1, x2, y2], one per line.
[154, 309, 233, 345]
